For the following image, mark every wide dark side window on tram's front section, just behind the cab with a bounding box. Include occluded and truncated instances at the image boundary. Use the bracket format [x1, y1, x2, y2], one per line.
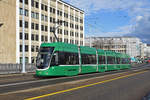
[58, 52, 79, 65]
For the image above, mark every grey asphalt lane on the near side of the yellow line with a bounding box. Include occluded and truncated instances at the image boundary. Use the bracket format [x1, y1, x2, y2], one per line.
[33, 71, 150, 100]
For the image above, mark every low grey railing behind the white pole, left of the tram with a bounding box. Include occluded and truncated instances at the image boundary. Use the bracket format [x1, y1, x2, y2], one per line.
[0, 64, 36, 74]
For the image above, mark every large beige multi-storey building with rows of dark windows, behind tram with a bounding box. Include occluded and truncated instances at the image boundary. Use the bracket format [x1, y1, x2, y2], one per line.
[0, 0, 84, 63]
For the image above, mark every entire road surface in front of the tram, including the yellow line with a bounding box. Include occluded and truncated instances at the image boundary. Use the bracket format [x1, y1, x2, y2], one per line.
[0, 65, 150, 100]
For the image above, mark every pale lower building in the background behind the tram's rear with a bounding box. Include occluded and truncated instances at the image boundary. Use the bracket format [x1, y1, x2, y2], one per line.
[85, 37, 143, 57]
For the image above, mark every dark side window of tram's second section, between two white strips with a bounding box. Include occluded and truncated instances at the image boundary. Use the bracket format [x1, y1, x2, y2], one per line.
[81, 54, 96, 64]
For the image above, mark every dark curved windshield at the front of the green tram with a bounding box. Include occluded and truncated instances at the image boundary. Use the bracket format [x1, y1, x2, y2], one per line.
[36, 47, 54, 69]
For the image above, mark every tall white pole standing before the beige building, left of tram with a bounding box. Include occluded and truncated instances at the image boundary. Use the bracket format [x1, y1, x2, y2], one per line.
[22, 0, 26, 73]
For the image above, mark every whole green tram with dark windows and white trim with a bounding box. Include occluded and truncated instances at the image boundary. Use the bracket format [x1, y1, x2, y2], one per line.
[36, 42, 131, 76]
